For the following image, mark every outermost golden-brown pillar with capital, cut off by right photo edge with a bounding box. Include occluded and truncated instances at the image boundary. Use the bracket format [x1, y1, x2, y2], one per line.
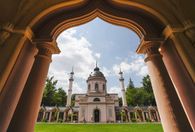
[163, 26, 195, 83]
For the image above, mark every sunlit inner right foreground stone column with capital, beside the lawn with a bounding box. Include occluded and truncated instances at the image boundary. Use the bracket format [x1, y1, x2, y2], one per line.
[137, 41, 191, 132]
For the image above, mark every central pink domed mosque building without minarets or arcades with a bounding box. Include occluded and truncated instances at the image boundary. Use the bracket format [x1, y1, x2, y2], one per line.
[75, 67, 119, 122]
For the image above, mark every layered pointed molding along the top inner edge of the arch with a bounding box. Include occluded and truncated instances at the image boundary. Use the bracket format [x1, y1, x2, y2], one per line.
[50, 8, 147, 38]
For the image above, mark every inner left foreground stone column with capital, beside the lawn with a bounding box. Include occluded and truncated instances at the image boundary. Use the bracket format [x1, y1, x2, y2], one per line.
[8, 42, 59, 132]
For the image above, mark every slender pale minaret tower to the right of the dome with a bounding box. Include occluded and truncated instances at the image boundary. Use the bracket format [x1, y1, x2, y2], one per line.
[119, 69, 127, 106]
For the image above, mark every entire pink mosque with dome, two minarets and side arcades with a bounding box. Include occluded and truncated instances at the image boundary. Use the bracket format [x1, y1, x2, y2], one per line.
[37, 65, 160, 123]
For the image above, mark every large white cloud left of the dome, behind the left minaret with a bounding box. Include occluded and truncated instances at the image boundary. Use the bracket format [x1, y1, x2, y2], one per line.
[49, 29, 101, 93]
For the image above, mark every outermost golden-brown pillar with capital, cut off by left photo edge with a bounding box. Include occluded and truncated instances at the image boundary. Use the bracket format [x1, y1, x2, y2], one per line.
[0, 23, 33, 93]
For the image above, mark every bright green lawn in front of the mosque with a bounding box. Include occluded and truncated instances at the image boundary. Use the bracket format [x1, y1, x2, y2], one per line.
[35, 123, 163, 132]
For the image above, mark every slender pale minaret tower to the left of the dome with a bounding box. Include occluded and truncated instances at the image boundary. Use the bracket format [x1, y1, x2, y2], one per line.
[66, 68, 74, 106]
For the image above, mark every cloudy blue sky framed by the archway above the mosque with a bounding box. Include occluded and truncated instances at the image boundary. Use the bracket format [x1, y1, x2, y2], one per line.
[48, 18, 148, 95]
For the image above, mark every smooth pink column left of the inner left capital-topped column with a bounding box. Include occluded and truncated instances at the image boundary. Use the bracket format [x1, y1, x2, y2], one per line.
[0, 42, 37, 131]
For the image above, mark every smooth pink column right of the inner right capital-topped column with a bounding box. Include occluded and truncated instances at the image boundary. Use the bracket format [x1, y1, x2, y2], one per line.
[161, 41, 195, 131]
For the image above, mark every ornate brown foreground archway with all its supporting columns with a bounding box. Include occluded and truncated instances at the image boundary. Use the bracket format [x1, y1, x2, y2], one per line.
[0, 0, 195, 131]
